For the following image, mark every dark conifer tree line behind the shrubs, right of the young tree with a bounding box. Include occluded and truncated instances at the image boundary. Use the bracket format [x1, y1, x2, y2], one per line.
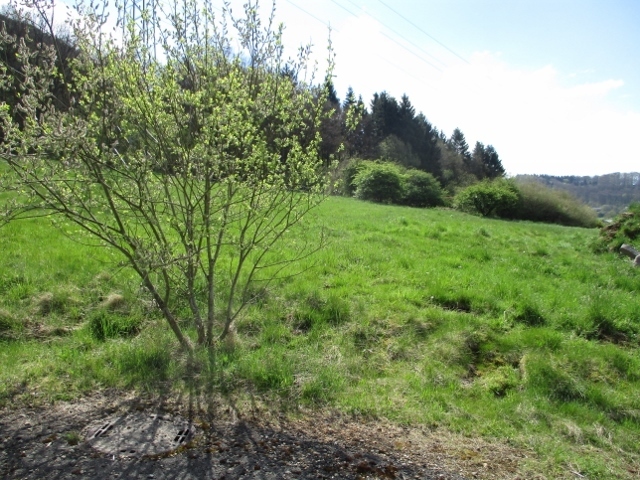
[321, 81, 505, 192]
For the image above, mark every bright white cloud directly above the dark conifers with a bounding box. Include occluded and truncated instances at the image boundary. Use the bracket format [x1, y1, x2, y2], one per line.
[334, 16, 640, 175]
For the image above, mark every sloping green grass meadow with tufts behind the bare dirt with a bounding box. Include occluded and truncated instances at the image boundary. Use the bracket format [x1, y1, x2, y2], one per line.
[0, 198, 640, 478]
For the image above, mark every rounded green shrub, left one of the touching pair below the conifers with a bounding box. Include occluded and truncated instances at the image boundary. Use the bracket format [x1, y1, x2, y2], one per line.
[352, 162, 403, 203]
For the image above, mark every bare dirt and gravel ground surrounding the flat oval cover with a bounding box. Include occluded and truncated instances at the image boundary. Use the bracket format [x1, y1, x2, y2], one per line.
[0, 391, 525, 480]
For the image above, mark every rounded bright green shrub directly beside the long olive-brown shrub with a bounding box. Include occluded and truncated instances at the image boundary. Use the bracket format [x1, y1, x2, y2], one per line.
[454, 180, 519, 217]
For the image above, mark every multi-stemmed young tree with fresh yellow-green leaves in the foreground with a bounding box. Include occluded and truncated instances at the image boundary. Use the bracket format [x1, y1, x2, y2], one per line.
[0, 0, 338, 349]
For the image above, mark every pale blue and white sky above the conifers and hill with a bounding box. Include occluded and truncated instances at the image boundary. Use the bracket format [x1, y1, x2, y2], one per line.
[5, 0, 640, 175]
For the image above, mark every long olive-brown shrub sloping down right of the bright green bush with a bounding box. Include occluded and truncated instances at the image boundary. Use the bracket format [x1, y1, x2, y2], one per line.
[508, 181, 599, 228]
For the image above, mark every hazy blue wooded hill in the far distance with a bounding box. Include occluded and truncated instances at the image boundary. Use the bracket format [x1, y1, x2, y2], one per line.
[516, 172, 640, 218]
